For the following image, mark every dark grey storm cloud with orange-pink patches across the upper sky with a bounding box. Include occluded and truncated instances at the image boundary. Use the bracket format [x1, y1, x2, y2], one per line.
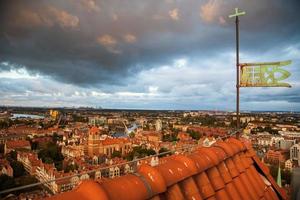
[0, 0, 300, 86]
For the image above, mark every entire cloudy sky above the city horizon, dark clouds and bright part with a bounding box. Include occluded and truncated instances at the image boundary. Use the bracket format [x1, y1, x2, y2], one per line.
[0, 0, 300, 111]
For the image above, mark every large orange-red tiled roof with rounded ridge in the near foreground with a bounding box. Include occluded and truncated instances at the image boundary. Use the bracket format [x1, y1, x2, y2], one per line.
[50, 138, 287, 200]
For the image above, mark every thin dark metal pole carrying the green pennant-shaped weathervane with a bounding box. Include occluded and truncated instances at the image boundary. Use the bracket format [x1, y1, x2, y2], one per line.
[235, 16, 240, 133]
